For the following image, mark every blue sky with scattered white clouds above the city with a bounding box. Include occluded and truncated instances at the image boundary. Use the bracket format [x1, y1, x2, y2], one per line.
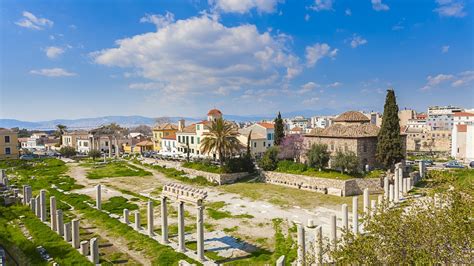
[0, 0, 474, 121]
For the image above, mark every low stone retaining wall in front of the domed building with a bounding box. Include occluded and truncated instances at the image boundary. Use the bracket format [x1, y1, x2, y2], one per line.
[261, 171, 383, 197]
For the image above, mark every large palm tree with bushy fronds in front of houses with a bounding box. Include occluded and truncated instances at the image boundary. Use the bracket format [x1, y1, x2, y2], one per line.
[201, 118, 240, 166]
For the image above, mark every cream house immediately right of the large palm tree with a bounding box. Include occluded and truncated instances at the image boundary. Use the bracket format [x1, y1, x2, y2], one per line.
[237, 122, 275, 158]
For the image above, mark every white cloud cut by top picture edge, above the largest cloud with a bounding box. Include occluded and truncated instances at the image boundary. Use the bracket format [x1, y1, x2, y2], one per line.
[209, 0, 278, 14]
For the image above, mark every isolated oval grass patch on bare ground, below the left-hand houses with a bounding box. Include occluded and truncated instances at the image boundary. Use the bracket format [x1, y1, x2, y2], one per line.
[87, 161, 152, 179]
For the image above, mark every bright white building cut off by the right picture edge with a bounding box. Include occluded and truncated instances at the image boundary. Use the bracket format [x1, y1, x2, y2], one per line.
[451, 112, 474, 162]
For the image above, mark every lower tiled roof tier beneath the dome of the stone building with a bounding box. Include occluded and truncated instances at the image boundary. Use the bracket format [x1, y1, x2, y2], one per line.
[306, 124, 380, 138]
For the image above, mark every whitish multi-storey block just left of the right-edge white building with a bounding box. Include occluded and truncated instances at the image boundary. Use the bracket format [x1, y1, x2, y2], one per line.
[426, 106, 462, 131]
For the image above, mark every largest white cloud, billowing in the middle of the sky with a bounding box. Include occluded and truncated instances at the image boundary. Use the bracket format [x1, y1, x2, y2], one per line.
[92, 15, 301, 97]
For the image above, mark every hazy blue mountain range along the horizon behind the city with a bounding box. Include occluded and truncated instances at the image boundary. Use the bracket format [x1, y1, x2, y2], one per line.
[0, 109, 337, 130]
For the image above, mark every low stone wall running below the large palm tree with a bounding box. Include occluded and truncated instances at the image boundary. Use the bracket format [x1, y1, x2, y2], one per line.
[150, 160, 248, 185]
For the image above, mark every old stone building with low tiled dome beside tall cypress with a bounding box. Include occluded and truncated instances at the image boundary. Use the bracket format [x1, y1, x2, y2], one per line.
[303, 111, 380, 170]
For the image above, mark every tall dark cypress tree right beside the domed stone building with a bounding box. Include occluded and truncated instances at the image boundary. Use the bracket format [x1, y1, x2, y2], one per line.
[376, 89, 404, 169]
